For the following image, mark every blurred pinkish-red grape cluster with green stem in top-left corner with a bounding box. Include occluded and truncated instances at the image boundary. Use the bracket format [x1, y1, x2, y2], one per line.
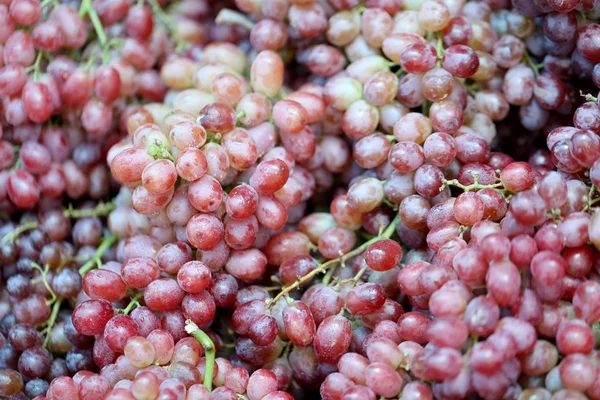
[0, 0, 243, 213]
